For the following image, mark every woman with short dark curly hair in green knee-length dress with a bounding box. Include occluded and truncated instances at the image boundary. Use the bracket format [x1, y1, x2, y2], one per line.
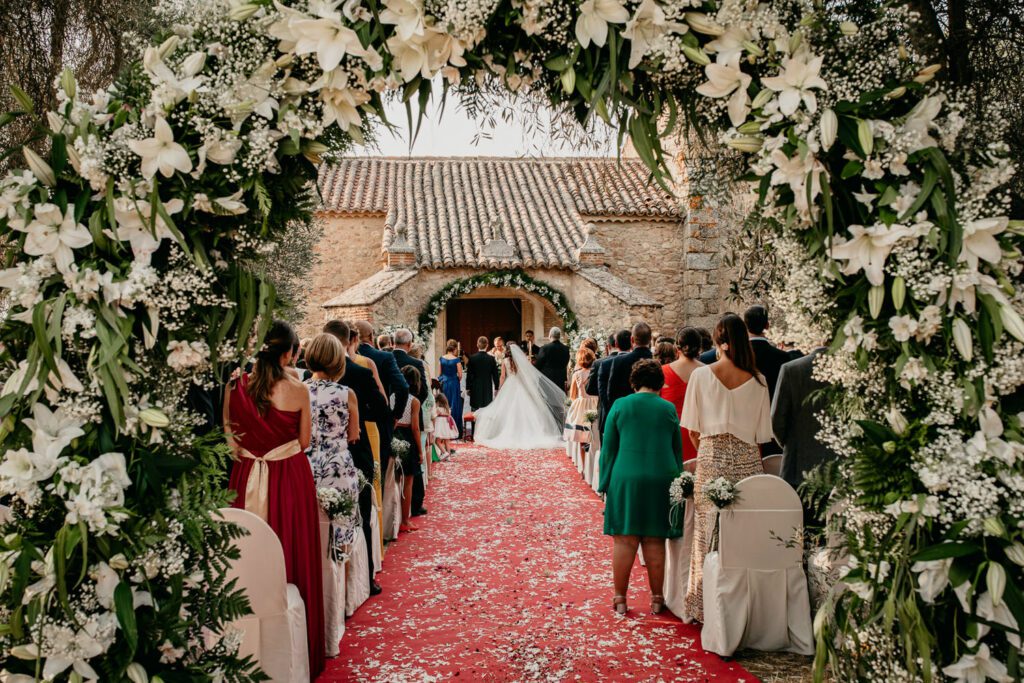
[598, 360, 683, 614]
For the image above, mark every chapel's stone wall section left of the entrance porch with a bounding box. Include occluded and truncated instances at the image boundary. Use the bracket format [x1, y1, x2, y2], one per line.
[298, 214, 384, 337]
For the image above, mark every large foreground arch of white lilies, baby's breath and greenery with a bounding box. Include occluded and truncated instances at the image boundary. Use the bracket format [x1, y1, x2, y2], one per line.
[0, 0, 1024, 682]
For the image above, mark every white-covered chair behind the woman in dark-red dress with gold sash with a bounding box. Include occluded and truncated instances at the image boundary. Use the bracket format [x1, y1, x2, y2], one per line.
[220, 508, 309, 683]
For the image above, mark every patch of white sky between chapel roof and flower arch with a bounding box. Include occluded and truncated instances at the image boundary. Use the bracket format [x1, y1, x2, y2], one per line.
[353, 97, 615, 157]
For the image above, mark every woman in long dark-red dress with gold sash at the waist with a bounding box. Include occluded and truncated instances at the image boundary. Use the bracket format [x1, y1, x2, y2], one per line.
[224, 321, 325, 680]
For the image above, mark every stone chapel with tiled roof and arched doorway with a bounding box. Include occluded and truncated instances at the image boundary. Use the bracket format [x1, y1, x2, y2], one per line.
[300, 157, 727, 357]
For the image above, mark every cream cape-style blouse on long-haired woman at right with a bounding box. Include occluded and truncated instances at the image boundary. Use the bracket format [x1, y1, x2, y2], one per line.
[679, 366, 772, 444]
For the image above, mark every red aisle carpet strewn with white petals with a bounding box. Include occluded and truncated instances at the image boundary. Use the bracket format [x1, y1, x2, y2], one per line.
[319, 446, 757, 683]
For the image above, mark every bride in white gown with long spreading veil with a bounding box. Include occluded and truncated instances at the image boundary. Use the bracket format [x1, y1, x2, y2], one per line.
[473, 344, 565, 450]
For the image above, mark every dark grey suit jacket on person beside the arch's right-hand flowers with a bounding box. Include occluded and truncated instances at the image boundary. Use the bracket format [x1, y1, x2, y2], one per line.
[771, 349, 836, 488]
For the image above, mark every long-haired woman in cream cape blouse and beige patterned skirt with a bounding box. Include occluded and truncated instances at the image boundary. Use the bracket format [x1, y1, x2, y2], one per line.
[680, 313, 772, 622]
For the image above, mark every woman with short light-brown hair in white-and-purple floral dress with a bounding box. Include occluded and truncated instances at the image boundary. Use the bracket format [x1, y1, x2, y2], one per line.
[306, 334, 361, 560]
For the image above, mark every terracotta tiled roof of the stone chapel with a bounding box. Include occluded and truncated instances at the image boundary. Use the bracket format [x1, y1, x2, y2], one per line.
[311, 158, 683, 268]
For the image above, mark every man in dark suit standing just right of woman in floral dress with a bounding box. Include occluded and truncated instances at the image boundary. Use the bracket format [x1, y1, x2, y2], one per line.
[324, 321, 391, 595]
